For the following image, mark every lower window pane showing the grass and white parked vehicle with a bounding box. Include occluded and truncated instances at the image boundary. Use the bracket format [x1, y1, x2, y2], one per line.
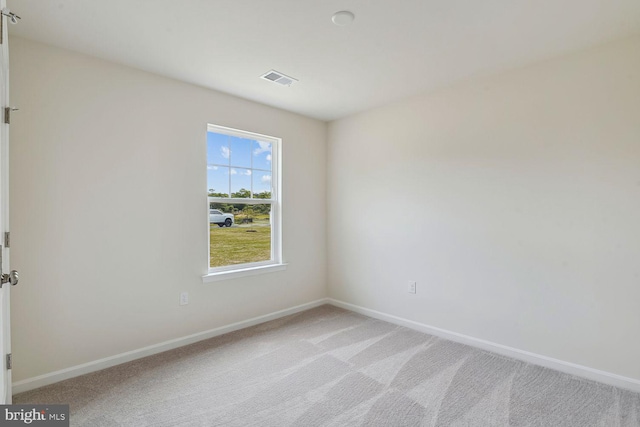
[209, 203, 271, 268]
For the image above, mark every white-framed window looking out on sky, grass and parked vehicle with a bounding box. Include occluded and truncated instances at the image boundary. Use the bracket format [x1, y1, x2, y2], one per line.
[205, 124, 282, 280]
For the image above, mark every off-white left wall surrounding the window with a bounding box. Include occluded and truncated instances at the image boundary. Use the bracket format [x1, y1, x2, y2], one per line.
[11, 38, 326, 381]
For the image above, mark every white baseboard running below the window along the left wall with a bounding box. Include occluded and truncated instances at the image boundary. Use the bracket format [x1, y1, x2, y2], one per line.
[12, 298, 329, 394]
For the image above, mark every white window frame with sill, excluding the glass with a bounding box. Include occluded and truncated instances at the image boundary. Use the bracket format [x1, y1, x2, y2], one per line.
[202, 123, 286, 282]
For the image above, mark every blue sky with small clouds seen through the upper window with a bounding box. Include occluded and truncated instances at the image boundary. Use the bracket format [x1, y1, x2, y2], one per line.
[207, 132, 271, 195]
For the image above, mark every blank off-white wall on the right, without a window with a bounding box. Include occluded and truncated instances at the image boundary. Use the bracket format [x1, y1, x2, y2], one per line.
[327, 37, 640, 379]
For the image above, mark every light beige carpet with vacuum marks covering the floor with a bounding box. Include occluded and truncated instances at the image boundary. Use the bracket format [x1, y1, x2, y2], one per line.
[14, 306, 640, 427]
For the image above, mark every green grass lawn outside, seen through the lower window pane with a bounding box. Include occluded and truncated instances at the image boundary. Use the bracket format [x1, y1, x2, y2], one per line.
[209, 224, 271, 267]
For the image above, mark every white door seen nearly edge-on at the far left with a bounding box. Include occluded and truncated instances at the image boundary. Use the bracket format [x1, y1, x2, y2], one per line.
[0, 0, 11, 403]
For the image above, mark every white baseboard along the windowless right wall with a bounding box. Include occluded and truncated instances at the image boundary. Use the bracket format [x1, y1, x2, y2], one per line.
[328, 298, 640, 392]
